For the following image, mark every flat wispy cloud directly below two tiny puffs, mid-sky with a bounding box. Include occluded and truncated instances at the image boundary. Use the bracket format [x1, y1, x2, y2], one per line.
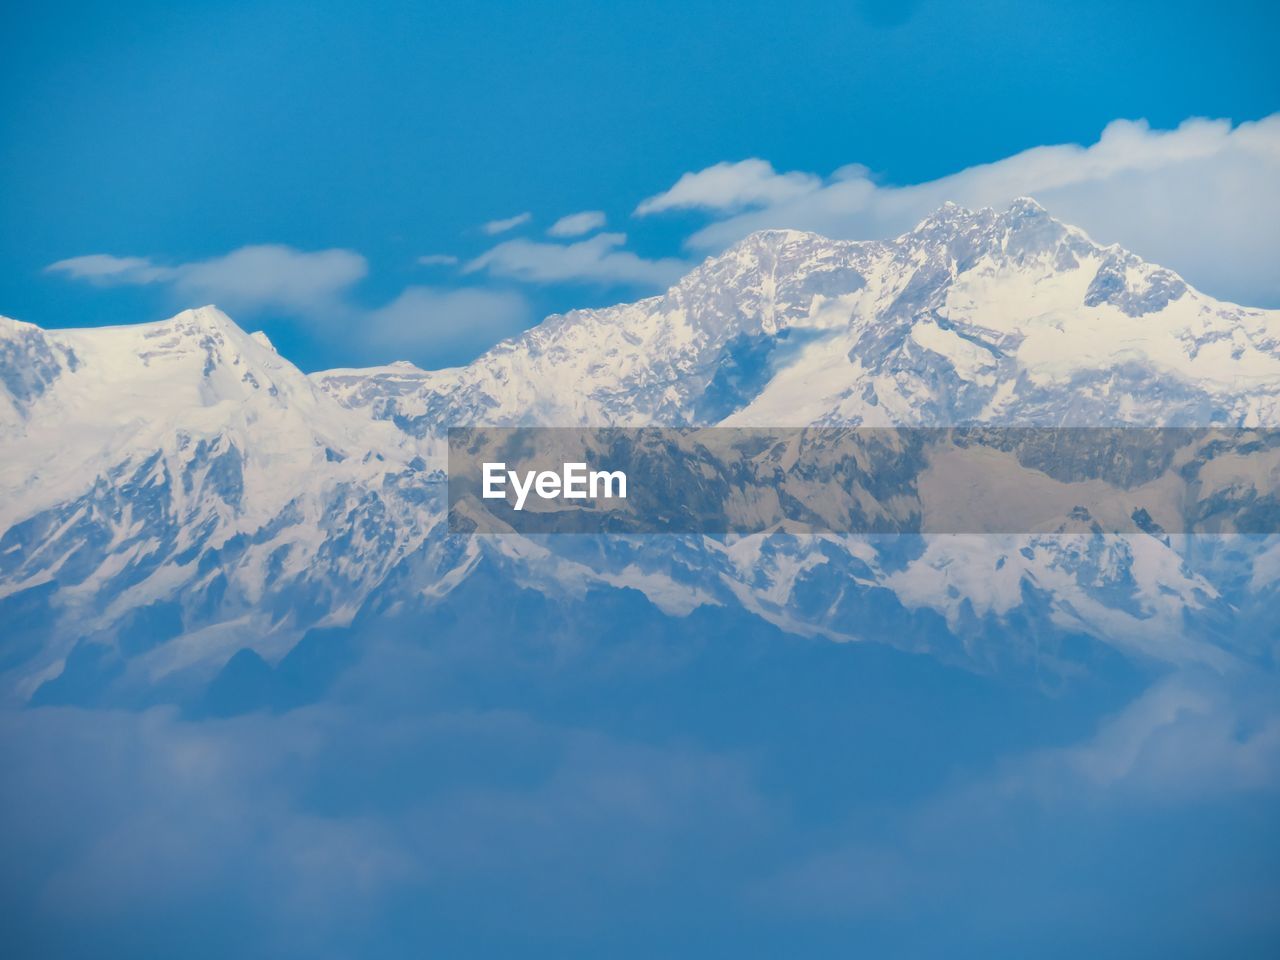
[466, 233, 689, 285]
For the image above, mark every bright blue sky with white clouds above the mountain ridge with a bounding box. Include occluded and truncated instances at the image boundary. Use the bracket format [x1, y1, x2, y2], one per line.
[0, 0, 1280, 369]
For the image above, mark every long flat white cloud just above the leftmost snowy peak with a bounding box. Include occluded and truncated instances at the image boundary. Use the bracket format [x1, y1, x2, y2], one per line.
[46, 244, 369, 311]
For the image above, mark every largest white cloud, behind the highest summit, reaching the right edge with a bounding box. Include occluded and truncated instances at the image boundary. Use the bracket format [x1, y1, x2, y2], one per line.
[650, 114, 1280, 305]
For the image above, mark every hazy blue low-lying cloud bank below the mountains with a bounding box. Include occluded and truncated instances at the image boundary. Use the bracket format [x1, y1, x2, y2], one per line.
[0, 620, 1280, 957]
